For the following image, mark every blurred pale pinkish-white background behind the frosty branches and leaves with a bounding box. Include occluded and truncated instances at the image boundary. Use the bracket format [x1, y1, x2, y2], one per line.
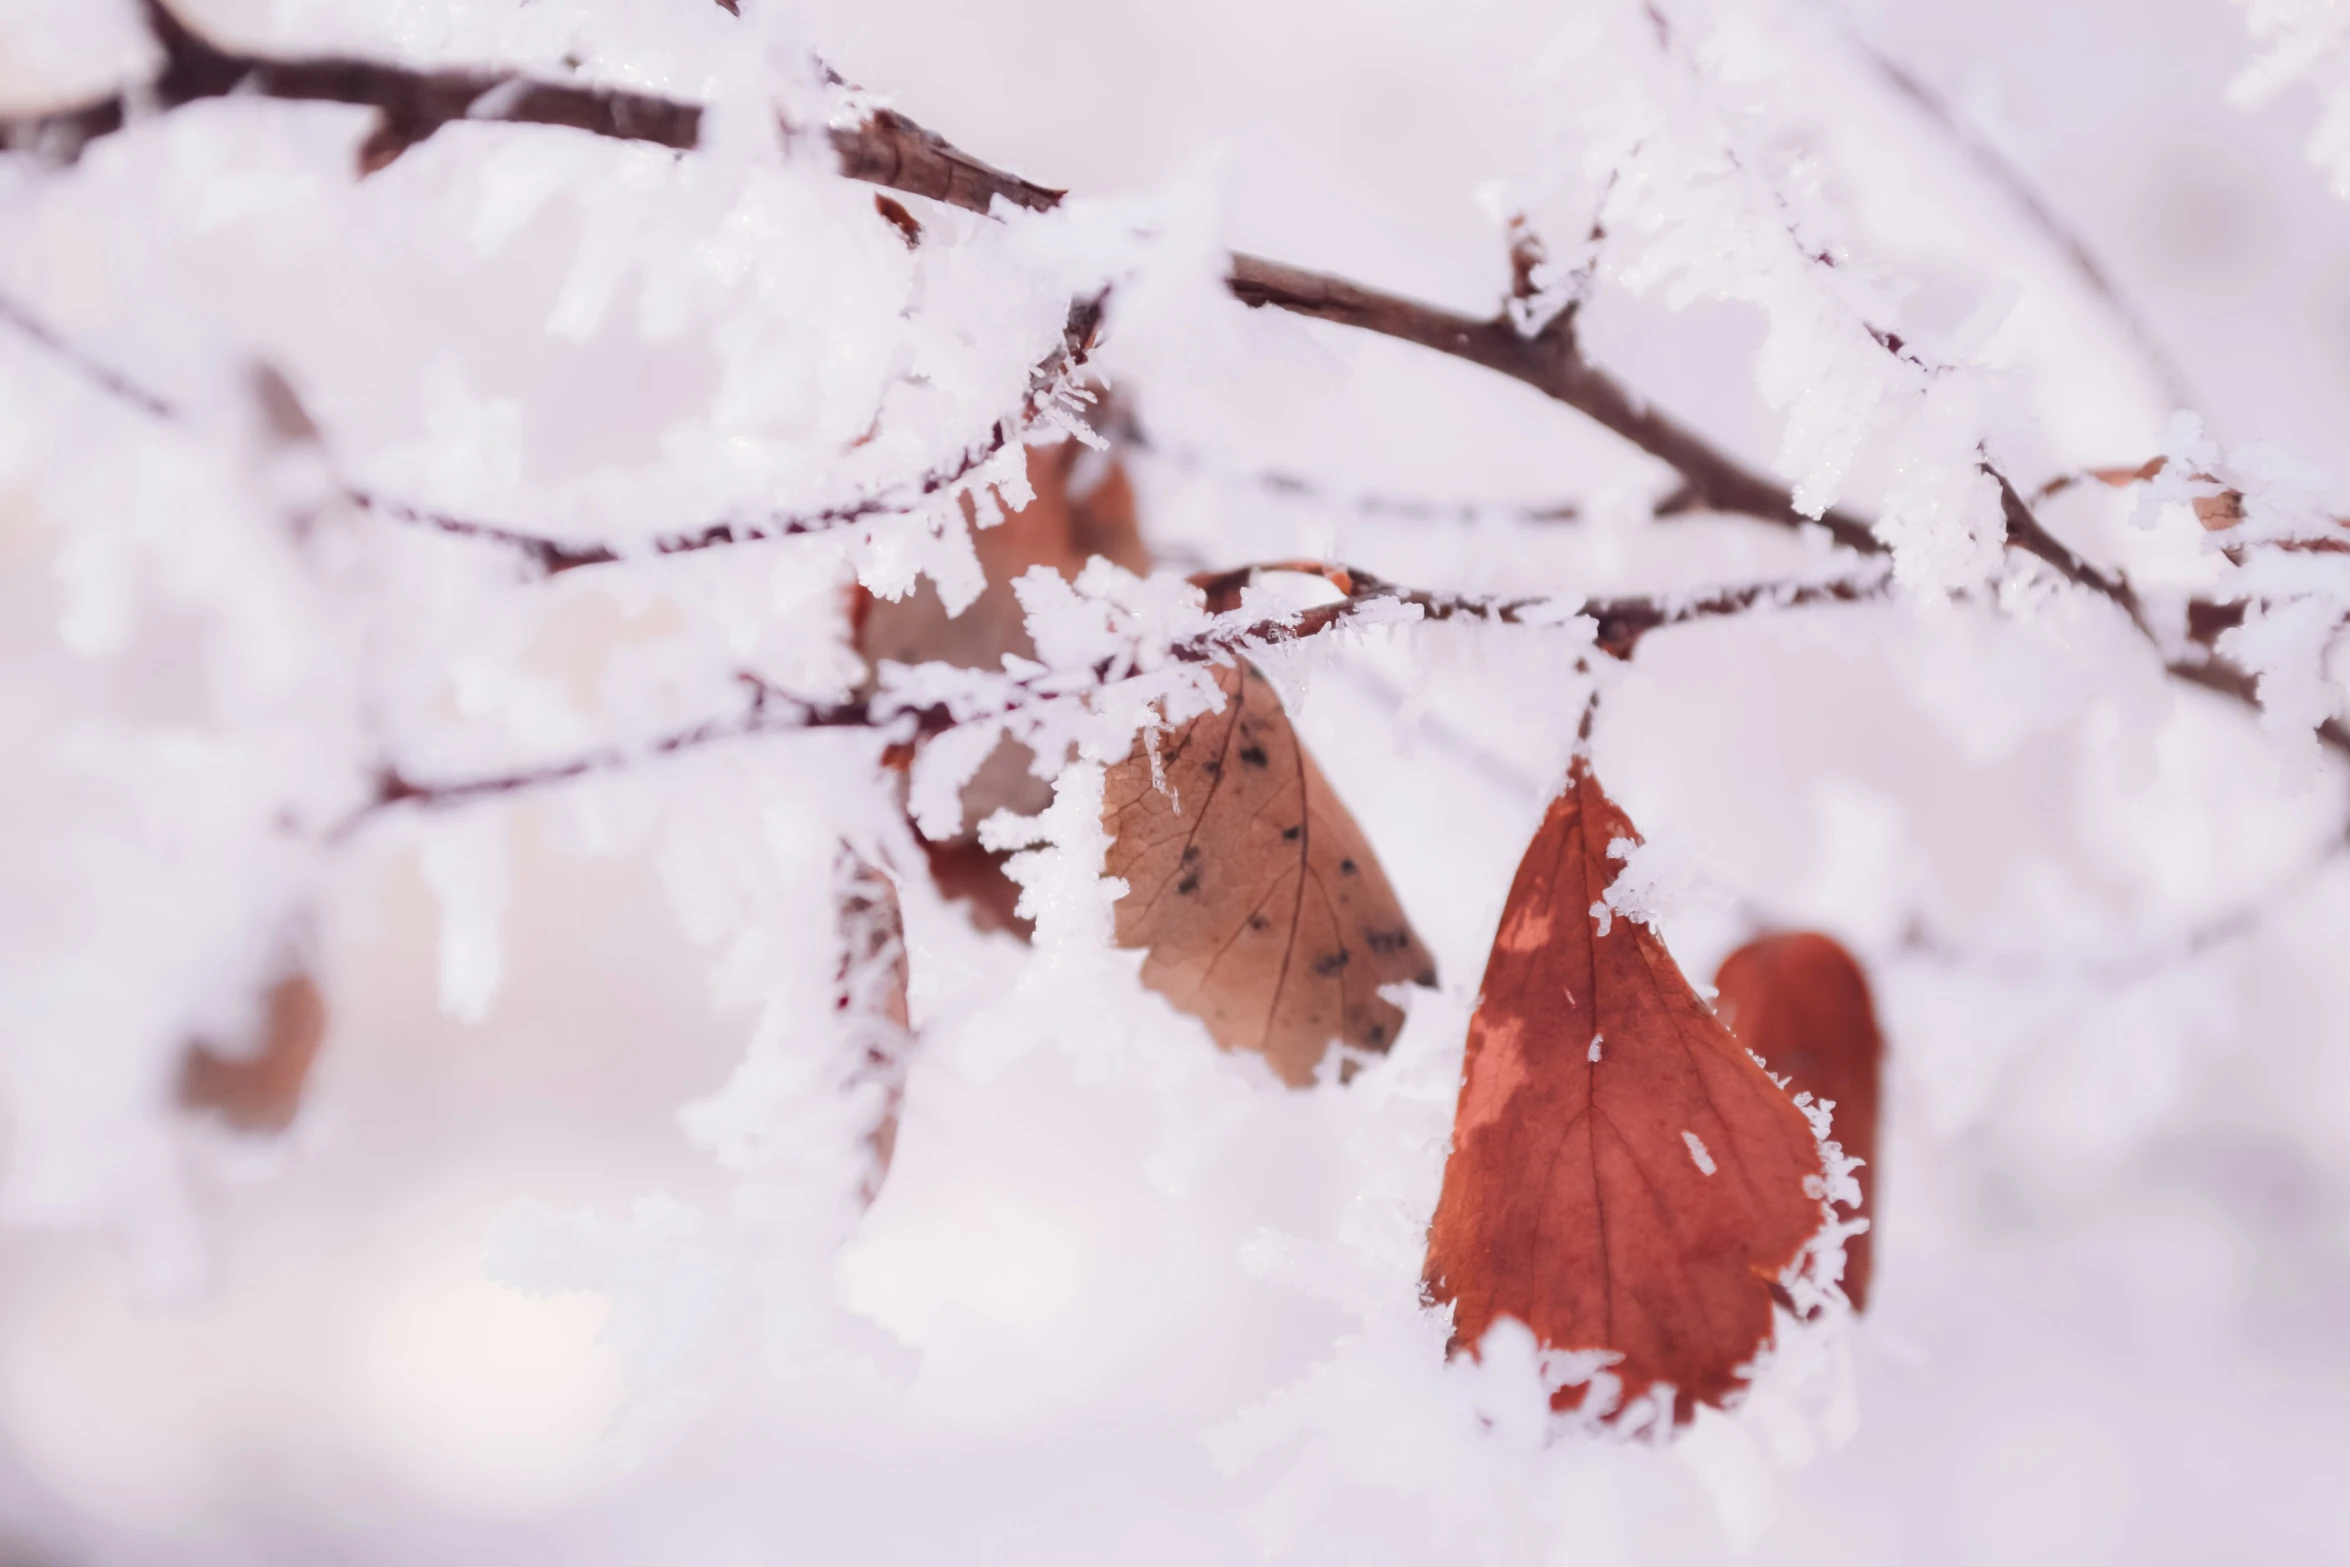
[0, 0, 2350, 1567]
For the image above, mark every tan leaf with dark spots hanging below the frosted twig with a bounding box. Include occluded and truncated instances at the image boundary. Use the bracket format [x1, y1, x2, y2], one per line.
[1102, 665, 1436, 1085]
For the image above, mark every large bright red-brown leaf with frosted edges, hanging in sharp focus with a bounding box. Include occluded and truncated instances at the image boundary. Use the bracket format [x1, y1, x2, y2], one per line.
[1426, 761, 1821, 1421]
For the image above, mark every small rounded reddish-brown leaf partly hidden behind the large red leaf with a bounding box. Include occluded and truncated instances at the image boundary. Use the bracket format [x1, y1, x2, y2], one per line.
[1713, 933, 1885, 1311]
